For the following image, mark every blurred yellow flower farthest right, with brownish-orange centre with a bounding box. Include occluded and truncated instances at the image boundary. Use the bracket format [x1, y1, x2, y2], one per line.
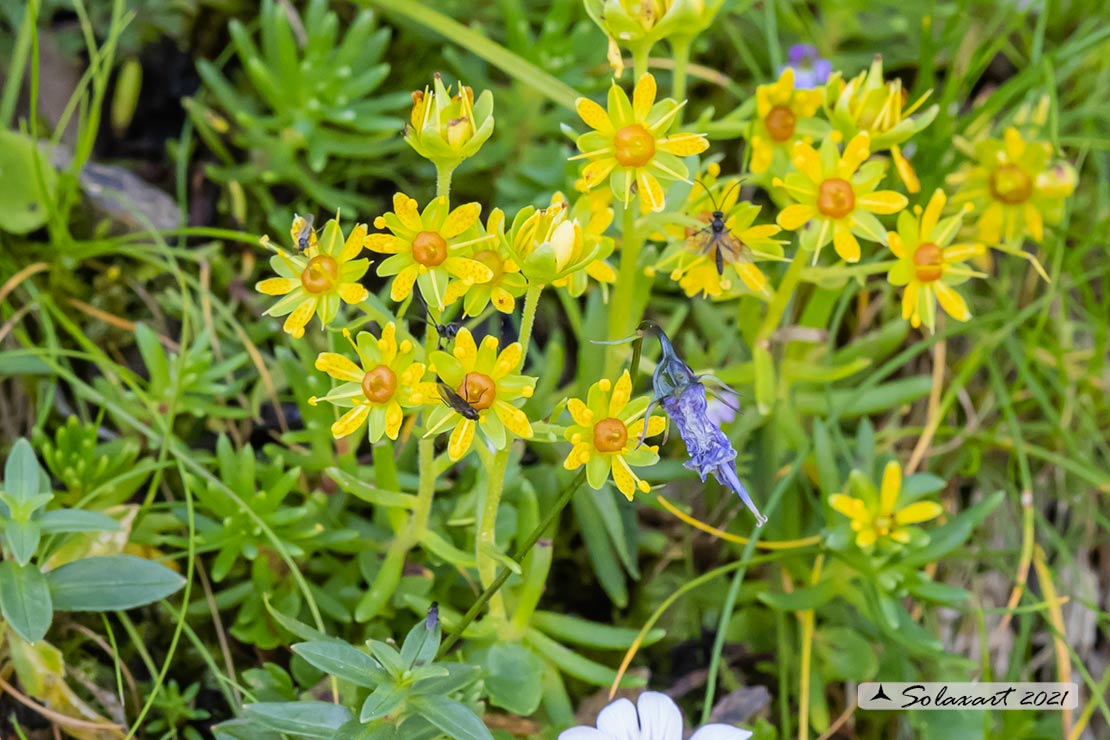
[948, 128, 1076, 245]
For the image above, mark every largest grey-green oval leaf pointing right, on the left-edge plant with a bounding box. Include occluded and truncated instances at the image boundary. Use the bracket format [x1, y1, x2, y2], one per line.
[47, 555, 185, 611]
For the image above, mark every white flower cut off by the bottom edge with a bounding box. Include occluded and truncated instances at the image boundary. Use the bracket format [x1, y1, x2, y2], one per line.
[558, 691, 751, 740]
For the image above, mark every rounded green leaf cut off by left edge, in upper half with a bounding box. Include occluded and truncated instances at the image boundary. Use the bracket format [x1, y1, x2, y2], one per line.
[0, 129, 58, 234]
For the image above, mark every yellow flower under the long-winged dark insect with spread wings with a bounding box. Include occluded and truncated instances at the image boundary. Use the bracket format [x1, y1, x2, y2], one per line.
[648, 176, 783, 297]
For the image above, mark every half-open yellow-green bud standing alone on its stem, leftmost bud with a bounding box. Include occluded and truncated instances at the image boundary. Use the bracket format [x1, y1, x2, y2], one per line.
[404, 72, 494, 170]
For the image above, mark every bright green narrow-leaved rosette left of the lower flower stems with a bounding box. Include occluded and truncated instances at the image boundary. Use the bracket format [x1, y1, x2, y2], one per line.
[180, 435, 356, 648]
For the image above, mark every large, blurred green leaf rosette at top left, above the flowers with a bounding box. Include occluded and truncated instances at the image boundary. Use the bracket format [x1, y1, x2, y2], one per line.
[184, 0, 412, 222]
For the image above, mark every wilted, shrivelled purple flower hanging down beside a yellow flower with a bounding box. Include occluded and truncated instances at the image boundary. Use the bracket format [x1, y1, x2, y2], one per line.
[640, 322, 767, 527]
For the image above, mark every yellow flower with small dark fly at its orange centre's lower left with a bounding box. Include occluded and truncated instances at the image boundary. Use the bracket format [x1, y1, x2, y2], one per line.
[414, 326, 536, 460]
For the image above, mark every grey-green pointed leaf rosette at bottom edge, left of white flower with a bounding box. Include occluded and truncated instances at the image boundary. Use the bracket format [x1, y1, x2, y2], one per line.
[214, 604, 493, 740]
